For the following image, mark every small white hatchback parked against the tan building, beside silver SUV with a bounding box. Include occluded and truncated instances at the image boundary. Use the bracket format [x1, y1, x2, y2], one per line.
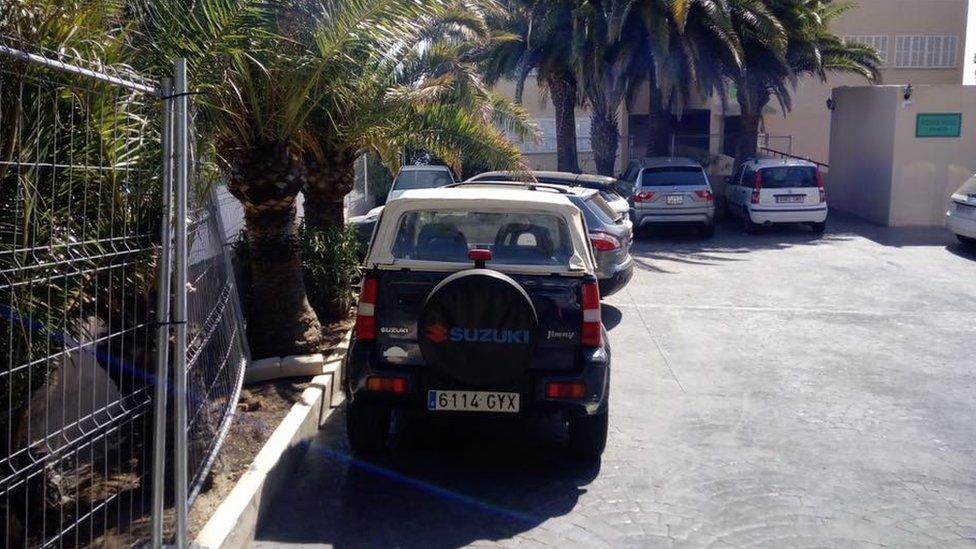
[725, 158, 827, 234]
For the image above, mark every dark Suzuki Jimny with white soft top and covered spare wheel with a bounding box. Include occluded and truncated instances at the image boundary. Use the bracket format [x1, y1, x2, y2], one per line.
[342, 187, 611, 458]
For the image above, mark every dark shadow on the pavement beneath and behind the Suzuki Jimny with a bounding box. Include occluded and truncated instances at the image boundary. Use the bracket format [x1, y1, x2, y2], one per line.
[257, 407, 599, 547]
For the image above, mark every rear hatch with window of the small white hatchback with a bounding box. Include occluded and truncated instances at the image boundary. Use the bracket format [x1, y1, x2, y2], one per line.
[756, 166, 822, 211]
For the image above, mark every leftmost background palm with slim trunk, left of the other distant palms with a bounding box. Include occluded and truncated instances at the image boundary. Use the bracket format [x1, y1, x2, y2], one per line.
[483, 0, 581, 172]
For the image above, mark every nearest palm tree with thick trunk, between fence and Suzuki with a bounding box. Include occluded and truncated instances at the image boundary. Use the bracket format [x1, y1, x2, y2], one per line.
[131, 0, 324, 357]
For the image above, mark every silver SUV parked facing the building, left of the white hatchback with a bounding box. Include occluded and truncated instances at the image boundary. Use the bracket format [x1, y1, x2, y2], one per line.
[631, 157, 715, 236]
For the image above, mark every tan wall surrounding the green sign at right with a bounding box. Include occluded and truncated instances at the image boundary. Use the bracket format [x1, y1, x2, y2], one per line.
[827, 86, 976, 226]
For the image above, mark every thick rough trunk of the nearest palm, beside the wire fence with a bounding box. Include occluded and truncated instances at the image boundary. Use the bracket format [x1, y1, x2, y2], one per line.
[228, 139, 321, 358]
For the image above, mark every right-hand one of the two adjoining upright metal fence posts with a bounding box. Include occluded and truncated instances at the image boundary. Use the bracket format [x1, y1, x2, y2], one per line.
[173, 58, 190, 549]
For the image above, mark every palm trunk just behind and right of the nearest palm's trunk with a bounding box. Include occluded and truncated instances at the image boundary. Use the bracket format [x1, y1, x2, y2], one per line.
[302, 149, 356, 228]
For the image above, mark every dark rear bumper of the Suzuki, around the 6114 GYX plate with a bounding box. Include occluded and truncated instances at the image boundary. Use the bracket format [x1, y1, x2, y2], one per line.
[342, 333, 610, 417]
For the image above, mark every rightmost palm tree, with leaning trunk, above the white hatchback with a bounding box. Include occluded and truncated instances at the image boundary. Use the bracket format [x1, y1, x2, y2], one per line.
[729, 0, 881, 163]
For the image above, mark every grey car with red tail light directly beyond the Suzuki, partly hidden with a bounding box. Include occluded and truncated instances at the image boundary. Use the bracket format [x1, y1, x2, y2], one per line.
[454, 180, 634, 297]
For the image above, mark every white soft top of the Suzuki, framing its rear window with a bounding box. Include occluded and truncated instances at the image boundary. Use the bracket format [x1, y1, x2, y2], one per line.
[366, 187, 594, 274]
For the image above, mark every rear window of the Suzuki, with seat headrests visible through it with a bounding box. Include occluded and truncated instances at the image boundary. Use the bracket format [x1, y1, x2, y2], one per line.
[393, 210, 573, 265]
